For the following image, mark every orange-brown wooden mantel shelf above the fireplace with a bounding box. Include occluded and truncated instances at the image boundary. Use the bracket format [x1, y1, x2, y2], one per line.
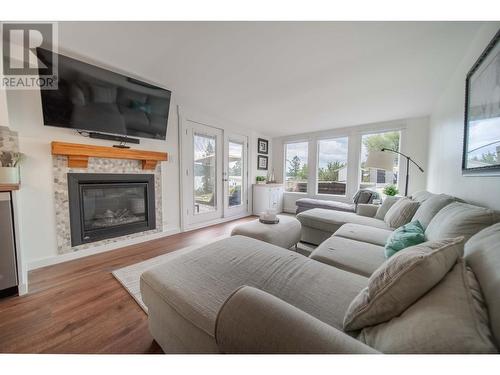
[52, 141, 168, 169]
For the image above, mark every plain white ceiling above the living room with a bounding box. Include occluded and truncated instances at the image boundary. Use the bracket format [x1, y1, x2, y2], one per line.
[59, 22, 481, 136]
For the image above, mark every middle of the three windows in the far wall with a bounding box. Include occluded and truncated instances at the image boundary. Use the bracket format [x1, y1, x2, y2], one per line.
[317, 137, 348, 195]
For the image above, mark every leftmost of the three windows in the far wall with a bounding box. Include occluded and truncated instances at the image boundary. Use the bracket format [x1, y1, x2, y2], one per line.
[285, 142, 308, 193]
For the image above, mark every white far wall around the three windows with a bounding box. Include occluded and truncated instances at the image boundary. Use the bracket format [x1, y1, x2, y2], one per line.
[273, 117, 429, 212]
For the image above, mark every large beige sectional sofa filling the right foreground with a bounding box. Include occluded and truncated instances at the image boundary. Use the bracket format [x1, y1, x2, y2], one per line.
[141, 193, 500, 353]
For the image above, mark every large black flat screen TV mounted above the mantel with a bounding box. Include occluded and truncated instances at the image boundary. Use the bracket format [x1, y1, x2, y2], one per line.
[37, 48, 171, 139]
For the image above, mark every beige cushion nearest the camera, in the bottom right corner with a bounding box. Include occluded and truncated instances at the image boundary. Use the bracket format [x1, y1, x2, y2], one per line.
[358, 259, 497, 353]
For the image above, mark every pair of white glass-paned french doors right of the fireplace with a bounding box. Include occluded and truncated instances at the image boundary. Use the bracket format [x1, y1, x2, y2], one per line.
[181, 120, 248, 229]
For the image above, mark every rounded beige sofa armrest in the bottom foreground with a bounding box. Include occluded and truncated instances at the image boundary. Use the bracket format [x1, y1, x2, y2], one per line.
[215, 286, 377, 354]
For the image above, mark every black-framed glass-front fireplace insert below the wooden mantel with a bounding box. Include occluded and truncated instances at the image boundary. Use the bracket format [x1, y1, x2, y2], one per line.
[68, 173, 156, 246]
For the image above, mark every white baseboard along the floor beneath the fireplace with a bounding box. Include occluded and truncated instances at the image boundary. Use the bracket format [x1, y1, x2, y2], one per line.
[28, 227, 180, 271]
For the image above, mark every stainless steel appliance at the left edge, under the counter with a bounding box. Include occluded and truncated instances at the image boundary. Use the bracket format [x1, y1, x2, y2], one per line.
[0, 193, 18, 297]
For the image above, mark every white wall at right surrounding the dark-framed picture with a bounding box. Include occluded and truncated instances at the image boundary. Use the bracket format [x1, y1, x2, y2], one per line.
[427, 22, 500, 209]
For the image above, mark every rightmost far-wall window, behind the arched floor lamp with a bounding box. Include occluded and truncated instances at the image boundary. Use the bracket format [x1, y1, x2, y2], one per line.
[359, 131, 401, 193]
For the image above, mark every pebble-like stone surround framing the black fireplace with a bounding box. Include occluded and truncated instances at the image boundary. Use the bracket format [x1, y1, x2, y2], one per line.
[52, 155, 162, 254]
